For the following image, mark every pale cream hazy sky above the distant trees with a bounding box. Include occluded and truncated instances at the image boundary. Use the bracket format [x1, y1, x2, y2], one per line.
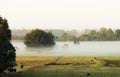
[0, 0, 120, 30]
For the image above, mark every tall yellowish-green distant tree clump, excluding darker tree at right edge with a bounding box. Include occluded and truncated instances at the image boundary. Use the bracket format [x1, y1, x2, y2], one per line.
[79, 27, 116, 41]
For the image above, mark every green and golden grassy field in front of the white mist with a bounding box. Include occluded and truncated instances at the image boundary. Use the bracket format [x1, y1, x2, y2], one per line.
[2, 56, 120, 77]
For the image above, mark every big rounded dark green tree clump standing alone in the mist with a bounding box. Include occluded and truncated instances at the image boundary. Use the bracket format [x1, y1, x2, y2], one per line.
[24, 29, 55, 47]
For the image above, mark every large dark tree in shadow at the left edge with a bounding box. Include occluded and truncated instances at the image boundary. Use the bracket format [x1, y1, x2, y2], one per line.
[0, 17, 16, 70]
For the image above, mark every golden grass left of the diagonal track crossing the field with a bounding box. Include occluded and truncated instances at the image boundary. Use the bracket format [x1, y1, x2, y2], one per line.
[14, 56, 57, 71]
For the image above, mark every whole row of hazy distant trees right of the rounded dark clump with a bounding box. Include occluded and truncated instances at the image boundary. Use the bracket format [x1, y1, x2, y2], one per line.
[59, 27, 120, 41]
